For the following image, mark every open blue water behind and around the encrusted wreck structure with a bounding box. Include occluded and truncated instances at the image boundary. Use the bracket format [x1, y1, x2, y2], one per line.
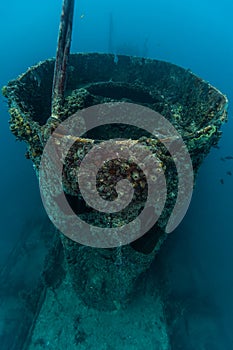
[0, 0, 233, 350]
